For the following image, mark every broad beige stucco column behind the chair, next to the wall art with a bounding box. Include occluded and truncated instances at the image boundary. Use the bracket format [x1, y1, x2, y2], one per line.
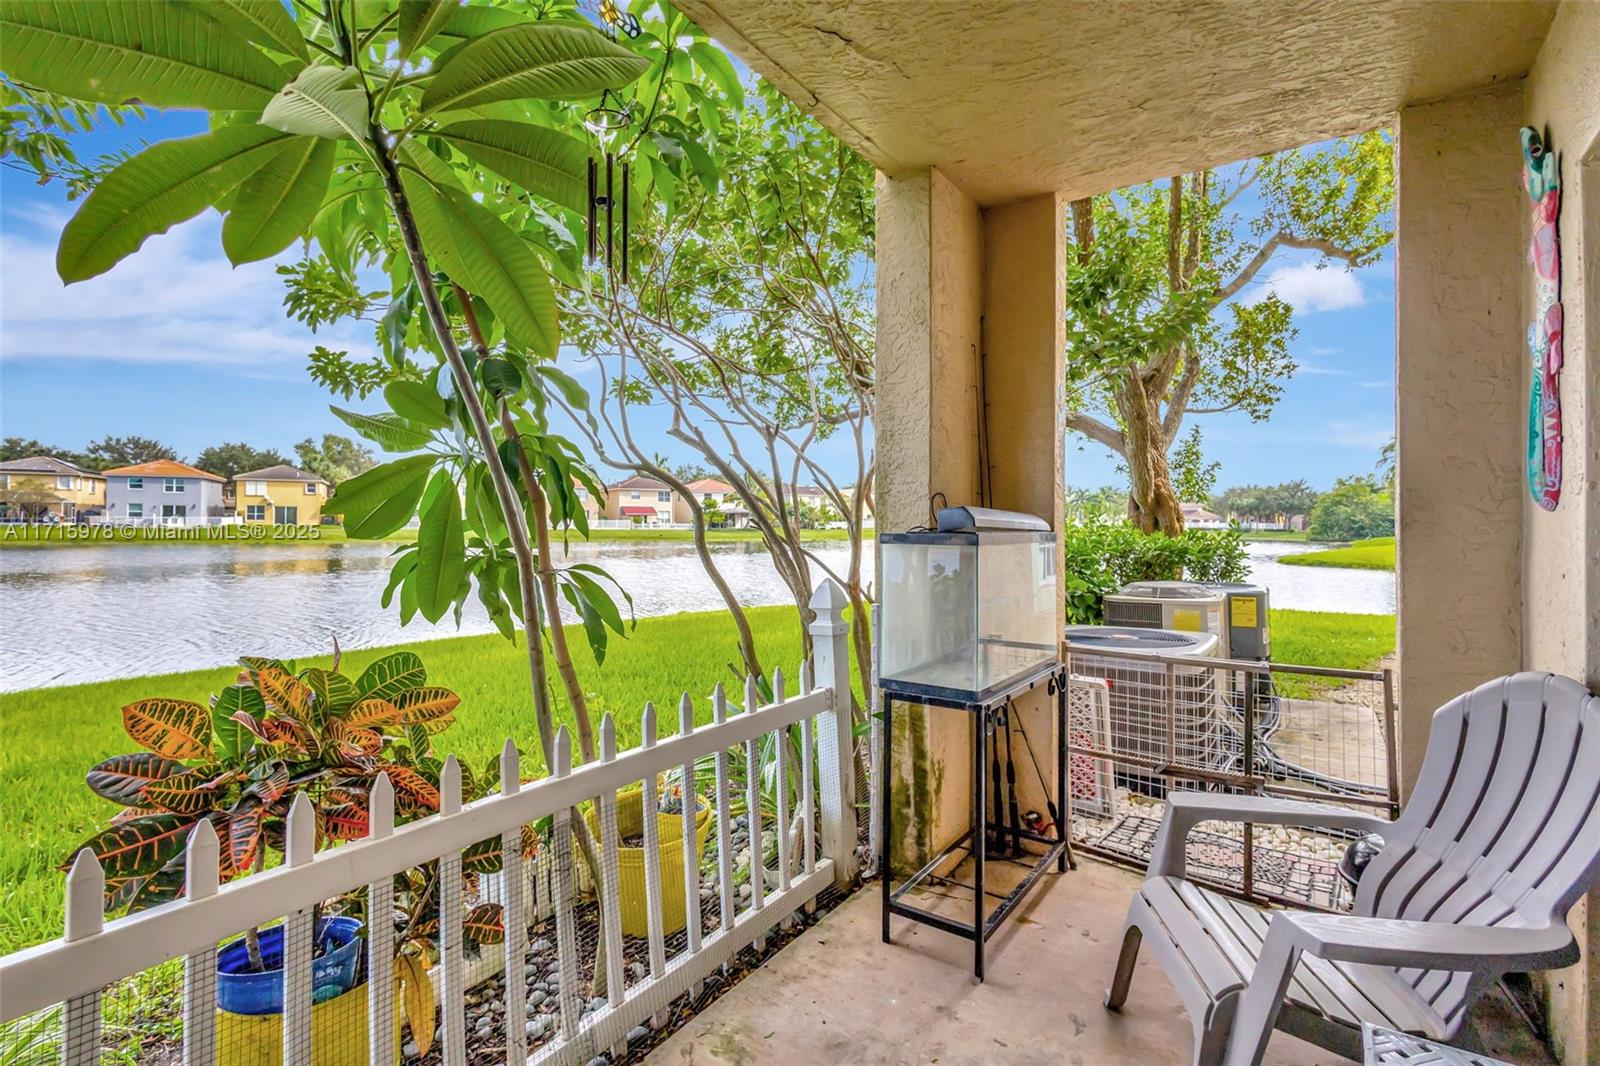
[1395, 85, 1526, 789]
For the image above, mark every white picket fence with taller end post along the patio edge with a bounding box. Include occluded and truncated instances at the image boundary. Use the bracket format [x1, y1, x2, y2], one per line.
[0, 581, 858, 1066]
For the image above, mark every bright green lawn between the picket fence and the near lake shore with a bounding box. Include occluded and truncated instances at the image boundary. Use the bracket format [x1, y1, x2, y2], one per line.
[0, 607, 864, 954]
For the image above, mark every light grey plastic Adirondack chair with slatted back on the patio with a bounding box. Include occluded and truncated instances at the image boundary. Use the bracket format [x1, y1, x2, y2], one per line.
[1106, 674, 1600, 1066]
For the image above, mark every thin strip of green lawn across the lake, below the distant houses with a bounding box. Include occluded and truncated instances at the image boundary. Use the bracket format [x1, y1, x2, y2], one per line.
[0, 523, 872, 547]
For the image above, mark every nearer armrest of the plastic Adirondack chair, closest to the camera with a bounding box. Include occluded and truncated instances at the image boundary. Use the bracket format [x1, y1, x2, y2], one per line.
[1272, 911, 1578, 973]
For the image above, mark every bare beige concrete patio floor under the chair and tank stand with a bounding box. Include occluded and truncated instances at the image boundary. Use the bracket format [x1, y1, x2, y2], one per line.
[646, 860, 1554, 1066]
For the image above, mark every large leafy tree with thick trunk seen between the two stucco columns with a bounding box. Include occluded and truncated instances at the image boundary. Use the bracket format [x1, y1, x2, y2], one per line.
[1066, 131, 1394, 535]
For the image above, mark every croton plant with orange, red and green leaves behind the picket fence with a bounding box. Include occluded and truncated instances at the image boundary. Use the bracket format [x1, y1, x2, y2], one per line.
[64, 651, 512, 946]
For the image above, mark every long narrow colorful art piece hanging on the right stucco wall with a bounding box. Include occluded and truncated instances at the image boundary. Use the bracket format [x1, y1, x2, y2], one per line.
[1522, 126, 1562, 511]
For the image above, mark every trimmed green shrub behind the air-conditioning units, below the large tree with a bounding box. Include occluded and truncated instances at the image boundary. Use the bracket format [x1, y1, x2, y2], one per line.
[1061, 523, 1250, 626]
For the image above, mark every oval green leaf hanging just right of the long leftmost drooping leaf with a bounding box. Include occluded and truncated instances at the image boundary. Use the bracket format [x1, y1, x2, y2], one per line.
[222, 136, 338, 266]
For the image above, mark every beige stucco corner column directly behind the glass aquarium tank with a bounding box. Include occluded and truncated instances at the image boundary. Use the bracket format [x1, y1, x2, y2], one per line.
[875, 170, 1064, 872]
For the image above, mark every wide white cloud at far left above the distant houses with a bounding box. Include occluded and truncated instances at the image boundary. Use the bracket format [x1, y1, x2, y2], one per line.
[0, 211, 374, 376]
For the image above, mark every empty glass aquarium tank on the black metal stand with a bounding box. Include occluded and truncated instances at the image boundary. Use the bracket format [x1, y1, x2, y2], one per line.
[878, 530, 1061, 703]
